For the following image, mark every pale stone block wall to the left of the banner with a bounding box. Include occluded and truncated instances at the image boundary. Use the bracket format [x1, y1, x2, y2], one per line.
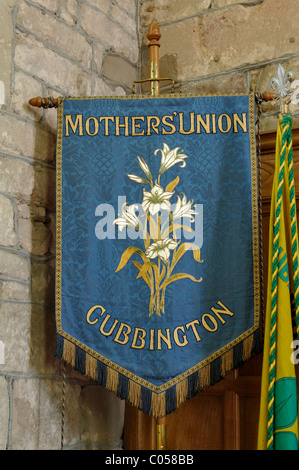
[0, 0, 139, 450]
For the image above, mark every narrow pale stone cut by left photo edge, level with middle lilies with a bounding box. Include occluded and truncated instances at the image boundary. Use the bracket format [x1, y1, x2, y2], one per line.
[0, 195, 17, 246]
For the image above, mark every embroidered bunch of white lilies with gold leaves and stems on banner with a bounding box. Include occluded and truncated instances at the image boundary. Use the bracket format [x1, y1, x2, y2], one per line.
[113, 143, 202, 317]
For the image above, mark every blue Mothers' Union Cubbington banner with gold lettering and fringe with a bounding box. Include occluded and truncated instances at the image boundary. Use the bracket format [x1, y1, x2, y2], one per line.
[56, 94, 261, 416]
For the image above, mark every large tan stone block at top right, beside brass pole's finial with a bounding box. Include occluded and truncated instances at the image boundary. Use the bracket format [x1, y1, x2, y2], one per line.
[156, 0, 299, 81]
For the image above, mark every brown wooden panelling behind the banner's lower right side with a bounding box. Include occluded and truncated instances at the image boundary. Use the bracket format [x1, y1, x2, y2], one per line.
[124, 129, 299, 450]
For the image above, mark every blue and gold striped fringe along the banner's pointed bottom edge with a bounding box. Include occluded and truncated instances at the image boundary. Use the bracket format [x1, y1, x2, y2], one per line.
[56, 330, 262, 418]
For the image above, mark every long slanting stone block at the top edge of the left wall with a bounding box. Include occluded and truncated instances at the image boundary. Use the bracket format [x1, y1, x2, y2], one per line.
[17, 2, 92, 68]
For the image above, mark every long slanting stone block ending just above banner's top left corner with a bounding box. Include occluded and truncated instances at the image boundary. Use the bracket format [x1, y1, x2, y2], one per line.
[15, 31, 92, 96]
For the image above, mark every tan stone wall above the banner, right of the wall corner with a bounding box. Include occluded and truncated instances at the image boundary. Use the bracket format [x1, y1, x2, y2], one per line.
[140, 0, 299, 131]
